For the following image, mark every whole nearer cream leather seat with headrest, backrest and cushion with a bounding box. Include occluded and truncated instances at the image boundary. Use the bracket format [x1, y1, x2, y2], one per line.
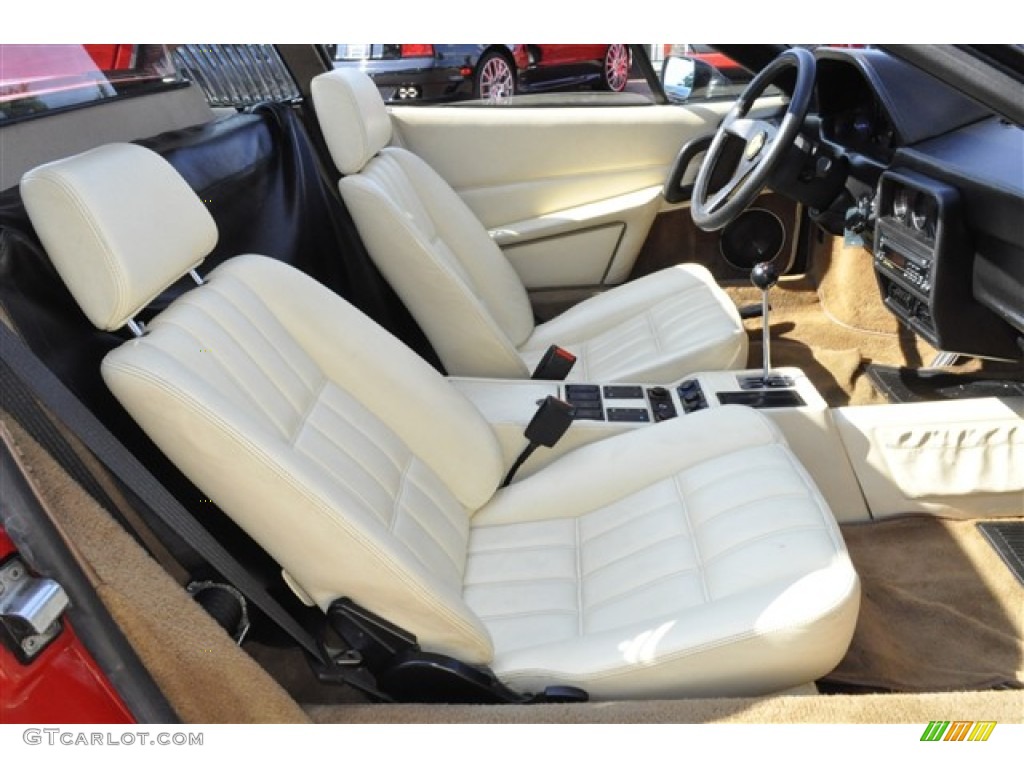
[22, 144, 859, 698]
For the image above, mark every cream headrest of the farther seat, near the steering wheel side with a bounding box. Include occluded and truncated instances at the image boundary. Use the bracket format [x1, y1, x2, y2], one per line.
[312, 70, 391, 175]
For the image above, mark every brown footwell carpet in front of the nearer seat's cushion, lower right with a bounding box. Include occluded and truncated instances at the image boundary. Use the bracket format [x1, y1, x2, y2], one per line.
[820, 515, 1024, 692]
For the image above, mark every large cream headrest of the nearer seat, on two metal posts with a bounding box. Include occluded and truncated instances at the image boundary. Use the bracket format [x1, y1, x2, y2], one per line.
[20, 143, 217, 331]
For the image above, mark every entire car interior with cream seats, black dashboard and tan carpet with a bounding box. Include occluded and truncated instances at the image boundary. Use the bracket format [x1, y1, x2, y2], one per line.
[0, 45, 1024, 723]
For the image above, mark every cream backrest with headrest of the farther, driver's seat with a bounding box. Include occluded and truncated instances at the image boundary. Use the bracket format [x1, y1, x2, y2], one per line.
[312, 70, 534, 378]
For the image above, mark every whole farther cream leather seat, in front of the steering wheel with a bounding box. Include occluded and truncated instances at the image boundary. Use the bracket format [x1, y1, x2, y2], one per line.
[312, 70, 748, 383]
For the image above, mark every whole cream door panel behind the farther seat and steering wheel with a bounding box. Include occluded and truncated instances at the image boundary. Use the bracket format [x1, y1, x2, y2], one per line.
[391, 102, 731, 290]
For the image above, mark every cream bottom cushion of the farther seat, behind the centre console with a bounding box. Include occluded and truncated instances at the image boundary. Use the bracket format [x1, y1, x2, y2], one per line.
[519, 264, 748, 383]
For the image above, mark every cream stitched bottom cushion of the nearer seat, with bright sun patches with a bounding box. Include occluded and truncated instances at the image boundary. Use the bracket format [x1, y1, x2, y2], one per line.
[465, 407, 859, 698]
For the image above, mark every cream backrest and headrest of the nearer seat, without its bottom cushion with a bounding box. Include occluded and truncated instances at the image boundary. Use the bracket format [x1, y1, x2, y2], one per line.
[22, 144, 503, 663]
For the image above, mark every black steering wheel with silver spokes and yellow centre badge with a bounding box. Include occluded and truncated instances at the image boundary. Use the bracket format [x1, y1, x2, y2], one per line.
[690, 48, 815, 231]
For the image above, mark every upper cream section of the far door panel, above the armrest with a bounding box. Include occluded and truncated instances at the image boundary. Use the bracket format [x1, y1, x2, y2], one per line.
[391, 102, 731, 228]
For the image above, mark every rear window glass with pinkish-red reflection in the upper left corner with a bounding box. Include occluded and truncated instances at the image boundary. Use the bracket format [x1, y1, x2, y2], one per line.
[0, 43, 185, 122]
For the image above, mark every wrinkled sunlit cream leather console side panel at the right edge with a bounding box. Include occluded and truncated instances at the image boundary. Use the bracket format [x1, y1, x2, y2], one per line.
[835, 397, 1024, 517]
